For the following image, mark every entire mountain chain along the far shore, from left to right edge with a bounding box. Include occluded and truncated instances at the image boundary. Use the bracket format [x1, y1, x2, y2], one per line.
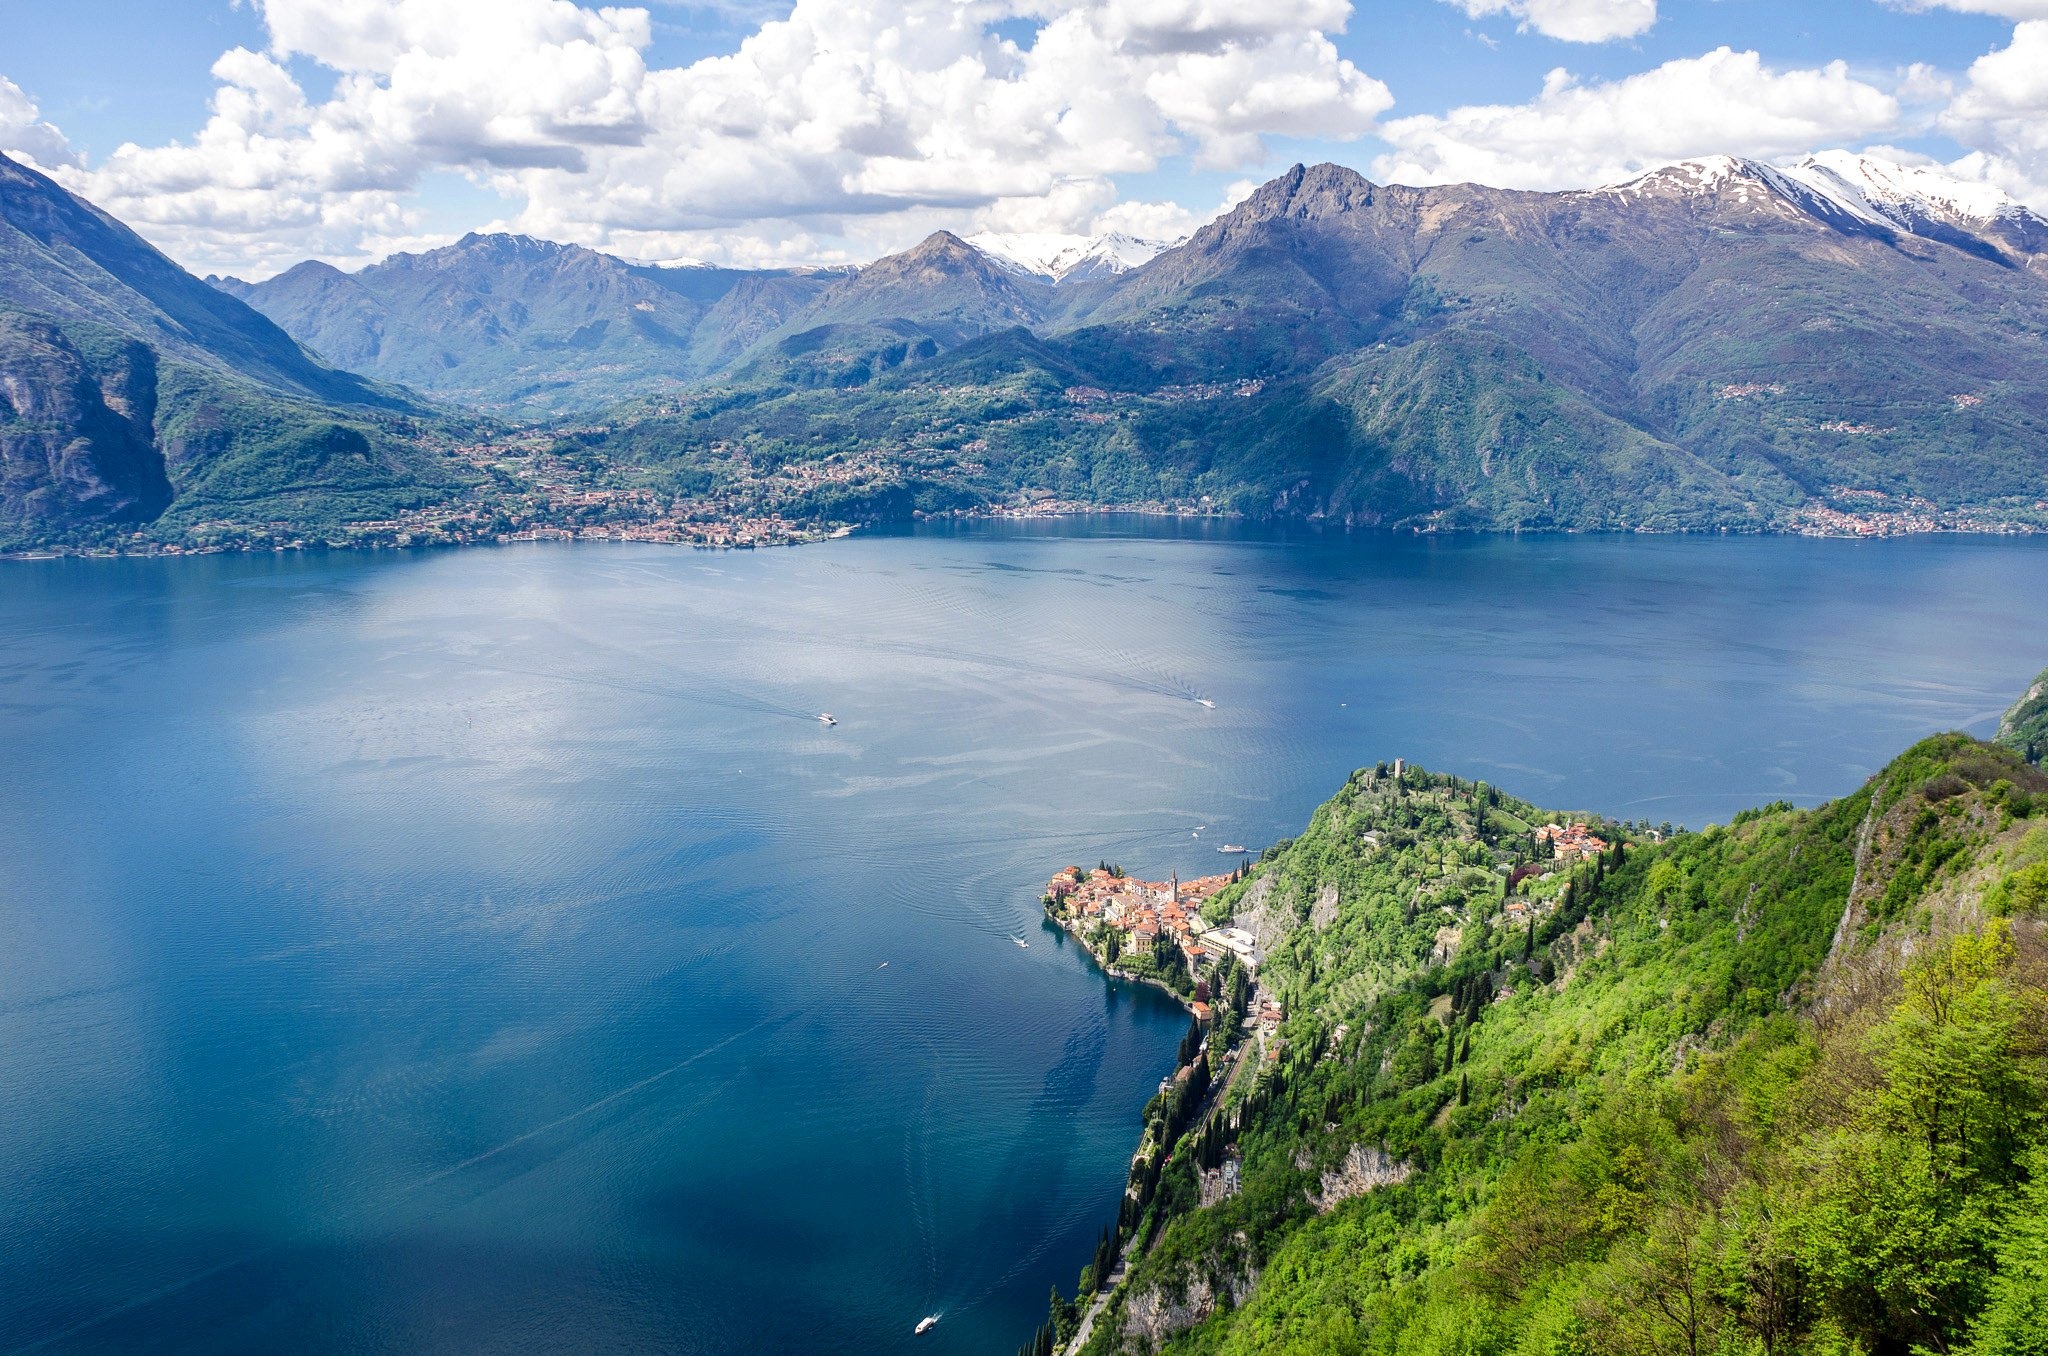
[0, 152, 2048, 548]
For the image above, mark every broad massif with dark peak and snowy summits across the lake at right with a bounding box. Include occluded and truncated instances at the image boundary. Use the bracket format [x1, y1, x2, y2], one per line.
[565, 158, 2048, 528]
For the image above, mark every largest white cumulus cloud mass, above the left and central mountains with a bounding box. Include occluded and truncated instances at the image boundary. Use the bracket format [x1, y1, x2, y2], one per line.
[44, 0, 1393, 272]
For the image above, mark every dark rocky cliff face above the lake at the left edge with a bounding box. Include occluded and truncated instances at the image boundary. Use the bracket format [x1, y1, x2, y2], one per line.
[0, 315, 172, 526]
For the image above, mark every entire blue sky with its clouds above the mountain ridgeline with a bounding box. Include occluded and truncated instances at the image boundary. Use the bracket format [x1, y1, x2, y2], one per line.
[0, 0, 2048, 277]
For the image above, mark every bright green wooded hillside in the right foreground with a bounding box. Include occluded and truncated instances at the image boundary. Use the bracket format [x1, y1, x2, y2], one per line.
[1040, 721, 2048, 1356]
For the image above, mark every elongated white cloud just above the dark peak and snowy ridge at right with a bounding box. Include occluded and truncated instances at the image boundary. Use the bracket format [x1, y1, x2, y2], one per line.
[1374, 47, 1903, 188]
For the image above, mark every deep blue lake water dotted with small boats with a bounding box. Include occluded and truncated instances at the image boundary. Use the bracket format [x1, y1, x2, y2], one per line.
[0, 524, 2048, 1352]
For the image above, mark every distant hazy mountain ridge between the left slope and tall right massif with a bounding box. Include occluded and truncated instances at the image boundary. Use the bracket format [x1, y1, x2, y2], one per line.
[207, 231, 1167, 416]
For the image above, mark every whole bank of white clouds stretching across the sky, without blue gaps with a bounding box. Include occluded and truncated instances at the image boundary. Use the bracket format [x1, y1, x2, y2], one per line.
[0, 0, 2048, 277]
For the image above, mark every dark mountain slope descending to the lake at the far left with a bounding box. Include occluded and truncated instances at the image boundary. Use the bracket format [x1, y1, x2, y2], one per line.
[0, 156, 461, 545]
